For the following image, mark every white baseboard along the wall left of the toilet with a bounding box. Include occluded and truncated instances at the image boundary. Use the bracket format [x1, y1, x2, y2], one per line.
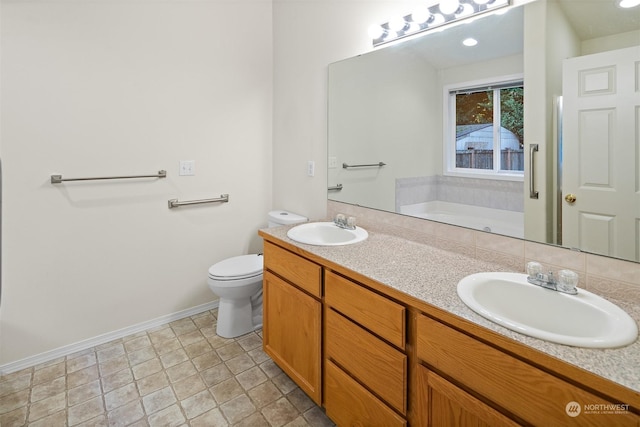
[0, 300, 219, 375]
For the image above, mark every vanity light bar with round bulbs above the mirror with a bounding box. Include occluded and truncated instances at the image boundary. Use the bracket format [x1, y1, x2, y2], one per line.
[369, 0, 510, 47]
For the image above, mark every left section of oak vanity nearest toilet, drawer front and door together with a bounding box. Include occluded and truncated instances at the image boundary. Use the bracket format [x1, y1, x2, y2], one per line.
[263, 242, 322, 405]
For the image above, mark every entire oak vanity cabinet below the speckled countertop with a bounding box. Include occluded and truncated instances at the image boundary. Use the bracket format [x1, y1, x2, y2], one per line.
[263, 236, 640, 427]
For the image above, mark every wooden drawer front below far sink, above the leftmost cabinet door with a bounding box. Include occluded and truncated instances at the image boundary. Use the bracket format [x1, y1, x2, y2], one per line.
[264, 242, 322, 298]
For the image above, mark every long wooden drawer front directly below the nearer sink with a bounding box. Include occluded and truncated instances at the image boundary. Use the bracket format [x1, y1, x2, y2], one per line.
[416, 315, 640, 427]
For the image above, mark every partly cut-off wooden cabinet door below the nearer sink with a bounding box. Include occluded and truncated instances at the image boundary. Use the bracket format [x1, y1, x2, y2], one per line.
[418, 366, 519, 427]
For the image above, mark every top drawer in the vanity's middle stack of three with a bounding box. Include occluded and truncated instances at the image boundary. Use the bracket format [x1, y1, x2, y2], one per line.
[324, 271, 406, 349]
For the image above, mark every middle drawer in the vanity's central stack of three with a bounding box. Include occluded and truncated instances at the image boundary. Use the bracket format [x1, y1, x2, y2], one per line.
[325, 309, 407, 414]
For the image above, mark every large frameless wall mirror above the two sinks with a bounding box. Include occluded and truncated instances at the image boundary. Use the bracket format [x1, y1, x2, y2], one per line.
[328, 0, 640, 262]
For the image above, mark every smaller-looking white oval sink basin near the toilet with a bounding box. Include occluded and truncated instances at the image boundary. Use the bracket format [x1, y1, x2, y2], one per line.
[287, 222, 369, 246]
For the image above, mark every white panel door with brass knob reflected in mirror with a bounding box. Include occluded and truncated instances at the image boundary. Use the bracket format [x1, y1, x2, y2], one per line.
[562, 46, 640, 261]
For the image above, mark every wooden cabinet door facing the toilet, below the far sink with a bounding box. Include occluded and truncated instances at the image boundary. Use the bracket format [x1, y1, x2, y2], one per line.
[263, 271, 322, 405]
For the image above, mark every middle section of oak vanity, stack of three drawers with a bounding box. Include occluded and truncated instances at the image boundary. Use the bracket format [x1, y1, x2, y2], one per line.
[324, 271, 407, 427]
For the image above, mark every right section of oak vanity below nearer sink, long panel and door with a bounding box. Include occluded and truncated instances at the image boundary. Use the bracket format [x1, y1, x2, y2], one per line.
[416, 315, 640, 427]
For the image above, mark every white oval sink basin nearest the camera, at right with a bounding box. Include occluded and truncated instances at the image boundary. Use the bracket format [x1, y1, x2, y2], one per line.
[458, 273, 638, 348]
